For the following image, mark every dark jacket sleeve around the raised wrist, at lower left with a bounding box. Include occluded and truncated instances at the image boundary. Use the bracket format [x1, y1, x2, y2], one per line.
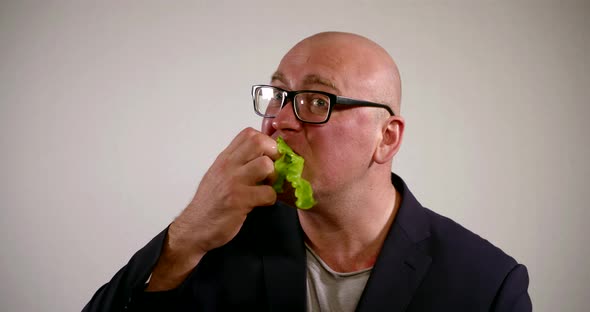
[82, 229, 168, 312]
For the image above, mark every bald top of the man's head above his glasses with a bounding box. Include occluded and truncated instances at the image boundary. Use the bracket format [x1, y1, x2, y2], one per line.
[273, 32, 401, 115]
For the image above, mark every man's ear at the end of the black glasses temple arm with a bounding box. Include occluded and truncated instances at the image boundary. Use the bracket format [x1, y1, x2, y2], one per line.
[373, 116, 405, 164]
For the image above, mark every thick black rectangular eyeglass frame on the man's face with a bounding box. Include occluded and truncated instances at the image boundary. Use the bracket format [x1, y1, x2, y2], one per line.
[252, 85, 395, 124]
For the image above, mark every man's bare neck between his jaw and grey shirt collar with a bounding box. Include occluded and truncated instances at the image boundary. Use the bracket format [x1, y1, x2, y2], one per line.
[299, 173, 400, 272]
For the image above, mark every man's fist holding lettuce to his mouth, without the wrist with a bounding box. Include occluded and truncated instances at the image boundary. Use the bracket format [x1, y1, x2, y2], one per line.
[171, 128, 279, 252]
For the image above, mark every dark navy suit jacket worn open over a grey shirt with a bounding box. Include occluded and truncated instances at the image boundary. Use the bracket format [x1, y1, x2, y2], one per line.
[84, 175, 532, 312]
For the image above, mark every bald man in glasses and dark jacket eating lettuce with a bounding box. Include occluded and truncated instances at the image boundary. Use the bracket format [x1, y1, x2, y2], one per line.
[85, 32, 531, 311]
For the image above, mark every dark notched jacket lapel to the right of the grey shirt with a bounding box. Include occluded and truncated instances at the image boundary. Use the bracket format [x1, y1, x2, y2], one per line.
[357, 175, 432, 312]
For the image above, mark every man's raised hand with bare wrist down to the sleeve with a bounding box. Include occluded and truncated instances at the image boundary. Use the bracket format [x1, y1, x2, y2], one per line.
[147, 128, 279, 290]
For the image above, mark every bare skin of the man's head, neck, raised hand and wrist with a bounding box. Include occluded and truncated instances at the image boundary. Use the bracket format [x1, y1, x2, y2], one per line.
[147, 32, 404, 291]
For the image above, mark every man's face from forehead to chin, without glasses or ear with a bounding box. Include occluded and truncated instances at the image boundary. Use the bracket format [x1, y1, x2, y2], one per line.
[262, 38, 380, 200]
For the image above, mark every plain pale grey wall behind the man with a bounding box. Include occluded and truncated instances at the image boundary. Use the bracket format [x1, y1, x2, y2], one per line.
[0, 0, 590, 311]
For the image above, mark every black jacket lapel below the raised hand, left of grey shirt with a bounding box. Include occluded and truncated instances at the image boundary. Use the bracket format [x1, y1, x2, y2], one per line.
[260, 203, 306, 311]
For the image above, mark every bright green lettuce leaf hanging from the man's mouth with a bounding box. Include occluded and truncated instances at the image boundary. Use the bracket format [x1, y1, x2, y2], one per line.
[272, 137, 316, 209]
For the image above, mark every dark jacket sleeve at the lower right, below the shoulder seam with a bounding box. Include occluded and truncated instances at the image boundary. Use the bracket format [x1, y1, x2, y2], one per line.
[491, 264, 533, 312]
